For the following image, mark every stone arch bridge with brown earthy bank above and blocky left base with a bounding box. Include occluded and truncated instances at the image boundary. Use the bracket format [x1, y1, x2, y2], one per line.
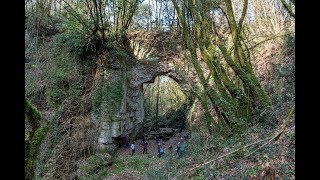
[98, 32, 194, 149]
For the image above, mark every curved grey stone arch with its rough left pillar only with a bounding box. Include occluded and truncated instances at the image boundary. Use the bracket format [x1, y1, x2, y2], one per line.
[122, 59, 190, 136]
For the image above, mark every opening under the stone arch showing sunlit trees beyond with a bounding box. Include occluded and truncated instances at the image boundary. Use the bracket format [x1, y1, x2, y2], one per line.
[143, 75, 189, 133]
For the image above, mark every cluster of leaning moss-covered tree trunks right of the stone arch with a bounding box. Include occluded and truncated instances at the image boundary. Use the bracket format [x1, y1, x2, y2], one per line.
[172, 0, 271, 131]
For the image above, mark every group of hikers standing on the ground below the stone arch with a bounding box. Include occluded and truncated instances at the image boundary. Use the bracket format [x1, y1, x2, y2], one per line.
[125, 135, 184, 158]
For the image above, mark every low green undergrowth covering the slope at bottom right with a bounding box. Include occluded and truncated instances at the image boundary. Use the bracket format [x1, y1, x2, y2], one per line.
[76, 121, 294, 179]
